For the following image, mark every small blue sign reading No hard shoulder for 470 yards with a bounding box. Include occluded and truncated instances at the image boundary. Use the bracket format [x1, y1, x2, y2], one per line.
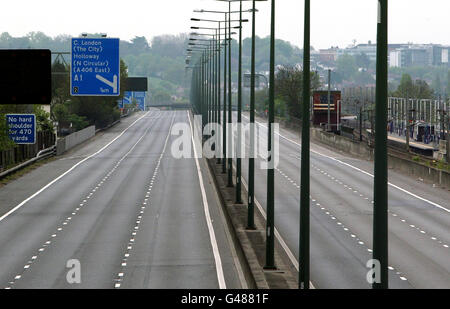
[6, 114, 36, 144]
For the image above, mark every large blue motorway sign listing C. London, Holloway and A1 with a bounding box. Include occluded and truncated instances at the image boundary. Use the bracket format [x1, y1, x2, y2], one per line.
[70, 38, 120, 96]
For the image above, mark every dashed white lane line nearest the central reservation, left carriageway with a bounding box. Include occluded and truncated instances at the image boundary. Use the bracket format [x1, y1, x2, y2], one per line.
[114, 114, 175, 289]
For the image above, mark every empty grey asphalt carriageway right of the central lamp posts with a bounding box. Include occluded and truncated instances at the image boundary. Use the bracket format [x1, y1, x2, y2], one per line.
[233, 114, 450, 288]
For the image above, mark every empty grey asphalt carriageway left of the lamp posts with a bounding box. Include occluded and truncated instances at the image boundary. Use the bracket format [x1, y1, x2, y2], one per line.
[0, 111, 246, 289]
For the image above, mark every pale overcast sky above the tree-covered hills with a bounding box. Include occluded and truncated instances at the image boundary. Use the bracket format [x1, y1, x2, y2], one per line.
[0, 0, 450, 48]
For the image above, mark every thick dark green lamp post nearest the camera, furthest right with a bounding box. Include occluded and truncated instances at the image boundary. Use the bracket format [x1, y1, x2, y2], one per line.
[372, 0, 389, 289]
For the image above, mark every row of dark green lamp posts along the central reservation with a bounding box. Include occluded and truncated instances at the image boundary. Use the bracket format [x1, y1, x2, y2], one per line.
[185, 0, 388, 289]
